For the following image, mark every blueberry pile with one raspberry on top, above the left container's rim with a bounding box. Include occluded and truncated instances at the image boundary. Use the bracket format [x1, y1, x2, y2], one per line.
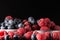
[0, 16, 23, 29]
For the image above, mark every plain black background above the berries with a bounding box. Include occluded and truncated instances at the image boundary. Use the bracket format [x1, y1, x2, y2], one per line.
[0, 0, 60, 25]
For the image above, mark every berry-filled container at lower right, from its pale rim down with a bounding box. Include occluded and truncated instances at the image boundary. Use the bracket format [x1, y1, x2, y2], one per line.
[31, 31, 60, 40]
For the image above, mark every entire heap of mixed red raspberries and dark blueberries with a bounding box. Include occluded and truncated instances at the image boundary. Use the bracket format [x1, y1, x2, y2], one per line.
[0, 16, 60, 40]
